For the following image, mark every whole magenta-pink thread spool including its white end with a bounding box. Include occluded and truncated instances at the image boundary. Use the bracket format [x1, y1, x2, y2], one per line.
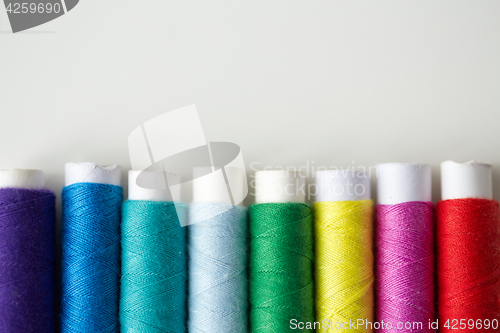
[376, 163, 435, 332]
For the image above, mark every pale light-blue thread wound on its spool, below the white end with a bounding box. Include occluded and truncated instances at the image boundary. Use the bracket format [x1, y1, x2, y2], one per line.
[188, 203, 248, 333]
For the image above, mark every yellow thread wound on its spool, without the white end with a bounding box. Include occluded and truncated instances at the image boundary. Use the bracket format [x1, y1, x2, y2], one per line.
[314, 200, 374, 332]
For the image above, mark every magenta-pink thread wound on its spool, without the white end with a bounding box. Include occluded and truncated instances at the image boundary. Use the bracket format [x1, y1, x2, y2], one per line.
[376, 201, 435, 332]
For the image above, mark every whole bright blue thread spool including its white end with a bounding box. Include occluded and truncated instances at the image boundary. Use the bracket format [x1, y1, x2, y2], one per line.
[60, 163, 123, 333]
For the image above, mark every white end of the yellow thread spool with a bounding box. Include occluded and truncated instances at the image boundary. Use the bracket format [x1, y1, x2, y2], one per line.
[315, 170, 370, 202]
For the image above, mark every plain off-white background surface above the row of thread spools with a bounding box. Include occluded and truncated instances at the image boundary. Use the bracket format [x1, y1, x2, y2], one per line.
[0, 0, 500, 205]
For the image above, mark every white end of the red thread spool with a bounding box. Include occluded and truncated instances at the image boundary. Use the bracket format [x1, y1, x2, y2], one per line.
[441, 161, 493, 200]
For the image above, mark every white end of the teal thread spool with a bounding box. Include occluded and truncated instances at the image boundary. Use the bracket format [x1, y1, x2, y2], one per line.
[128, 170, 181, 202]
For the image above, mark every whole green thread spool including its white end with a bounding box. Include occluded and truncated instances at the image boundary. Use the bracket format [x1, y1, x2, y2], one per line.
[249, 170, 314, 332]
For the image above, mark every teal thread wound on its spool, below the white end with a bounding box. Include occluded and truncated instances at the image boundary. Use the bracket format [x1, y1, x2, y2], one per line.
[120, 200, 187, 333]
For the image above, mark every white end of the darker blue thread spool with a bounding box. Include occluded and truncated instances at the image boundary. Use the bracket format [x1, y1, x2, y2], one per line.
[64, 162, 122, 186]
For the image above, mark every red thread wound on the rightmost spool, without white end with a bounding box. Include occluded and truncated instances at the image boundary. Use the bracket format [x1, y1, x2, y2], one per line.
[437, 199, 500, 332]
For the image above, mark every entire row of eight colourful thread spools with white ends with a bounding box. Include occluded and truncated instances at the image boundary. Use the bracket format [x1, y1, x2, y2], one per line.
[0, 162, 500, 332]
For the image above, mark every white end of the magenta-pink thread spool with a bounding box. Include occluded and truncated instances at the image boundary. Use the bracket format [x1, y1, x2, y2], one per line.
[377, 163, 432, 205]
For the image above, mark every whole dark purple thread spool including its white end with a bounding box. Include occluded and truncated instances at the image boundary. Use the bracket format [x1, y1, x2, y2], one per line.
[0, 169, 56, 333]
